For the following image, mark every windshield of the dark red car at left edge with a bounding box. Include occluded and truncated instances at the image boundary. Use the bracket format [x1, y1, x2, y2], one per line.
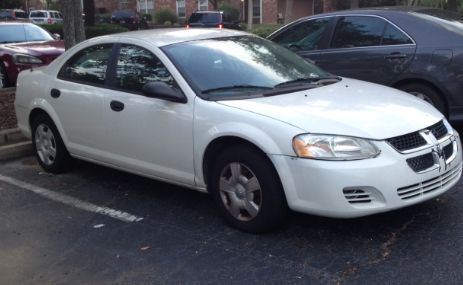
[0, 24, 53, 44]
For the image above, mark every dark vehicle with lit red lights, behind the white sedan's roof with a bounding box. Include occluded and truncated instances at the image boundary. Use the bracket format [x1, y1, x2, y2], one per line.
[187, 11, 240, 30]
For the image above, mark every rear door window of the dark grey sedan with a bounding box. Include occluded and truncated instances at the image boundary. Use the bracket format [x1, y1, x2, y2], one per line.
[331, 16, 387, 48]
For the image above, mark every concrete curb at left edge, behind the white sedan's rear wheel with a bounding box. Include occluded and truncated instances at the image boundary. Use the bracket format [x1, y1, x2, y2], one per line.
[0, 128, 33, 161]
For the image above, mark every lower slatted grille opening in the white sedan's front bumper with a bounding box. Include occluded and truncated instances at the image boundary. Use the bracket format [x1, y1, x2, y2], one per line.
[397, 165, 461, 200]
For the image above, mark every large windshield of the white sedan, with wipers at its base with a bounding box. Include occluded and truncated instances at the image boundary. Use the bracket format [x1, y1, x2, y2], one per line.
[163, 36, 339, 100]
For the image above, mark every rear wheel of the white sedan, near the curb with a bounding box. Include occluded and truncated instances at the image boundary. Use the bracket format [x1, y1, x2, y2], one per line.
[32, 114, 72, 174]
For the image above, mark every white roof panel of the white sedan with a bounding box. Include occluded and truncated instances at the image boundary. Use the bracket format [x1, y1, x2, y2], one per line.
[113, 28, 251, 47]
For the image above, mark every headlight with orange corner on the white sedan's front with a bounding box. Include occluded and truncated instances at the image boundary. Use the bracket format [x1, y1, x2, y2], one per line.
[293, 134, 380, 160]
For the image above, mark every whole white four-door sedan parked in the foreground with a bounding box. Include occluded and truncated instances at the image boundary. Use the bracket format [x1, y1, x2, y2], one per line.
[15, 29, 462, 232]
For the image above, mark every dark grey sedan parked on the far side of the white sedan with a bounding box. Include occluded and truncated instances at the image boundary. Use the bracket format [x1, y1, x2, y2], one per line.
[269, 7, 463, 121]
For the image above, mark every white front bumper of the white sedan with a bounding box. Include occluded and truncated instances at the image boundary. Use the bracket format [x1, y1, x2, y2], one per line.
[270, 131, 462, 218]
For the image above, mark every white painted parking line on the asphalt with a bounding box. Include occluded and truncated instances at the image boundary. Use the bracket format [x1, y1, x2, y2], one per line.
[0, 174, 143, 223]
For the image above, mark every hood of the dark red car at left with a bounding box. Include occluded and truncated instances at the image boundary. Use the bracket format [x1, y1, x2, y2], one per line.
[2, 41, 64, 56]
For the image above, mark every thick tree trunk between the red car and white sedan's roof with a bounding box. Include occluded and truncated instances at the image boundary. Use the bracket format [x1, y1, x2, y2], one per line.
[62, 0, 85, 49]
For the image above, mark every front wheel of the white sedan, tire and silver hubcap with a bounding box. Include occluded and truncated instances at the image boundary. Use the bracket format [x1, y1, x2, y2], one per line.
[208, 145, 289, 233]
